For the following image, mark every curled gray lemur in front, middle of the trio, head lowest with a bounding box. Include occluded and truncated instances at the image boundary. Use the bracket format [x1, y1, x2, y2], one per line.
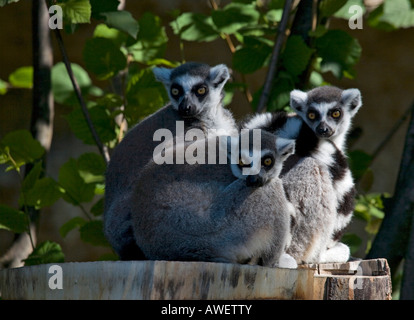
[132, 130, 296, 268]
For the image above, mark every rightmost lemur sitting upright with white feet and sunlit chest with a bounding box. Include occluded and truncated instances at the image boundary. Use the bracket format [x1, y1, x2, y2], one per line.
[243, 86, 362, 262]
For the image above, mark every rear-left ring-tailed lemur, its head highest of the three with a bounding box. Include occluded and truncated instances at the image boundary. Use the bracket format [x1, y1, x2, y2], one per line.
[104, 62, 238, 260]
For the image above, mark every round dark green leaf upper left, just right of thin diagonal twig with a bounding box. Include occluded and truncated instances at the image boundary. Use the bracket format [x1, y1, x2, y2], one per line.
[83, 38, 127, 80]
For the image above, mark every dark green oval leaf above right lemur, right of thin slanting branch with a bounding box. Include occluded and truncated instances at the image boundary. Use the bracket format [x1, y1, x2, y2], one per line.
[282, 36, 314, 76]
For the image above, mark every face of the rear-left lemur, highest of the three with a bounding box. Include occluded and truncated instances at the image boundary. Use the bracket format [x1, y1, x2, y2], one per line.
[153, 62, 230, 118]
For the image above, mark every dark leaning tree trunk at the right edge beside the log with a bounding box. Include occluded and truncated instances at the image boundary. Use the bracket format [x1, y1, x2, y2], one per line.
[367, 103, 414, 292]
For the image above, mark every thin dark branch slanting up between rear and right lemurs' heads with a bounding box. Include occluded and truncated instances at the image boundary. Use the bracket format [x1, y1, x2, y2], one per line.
[257, 0, 293, 112]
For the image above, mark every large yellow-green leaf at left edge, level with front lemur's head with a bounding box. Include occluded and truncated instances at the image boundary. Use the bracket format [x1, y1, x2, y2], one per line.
[0, 130, 45, 169]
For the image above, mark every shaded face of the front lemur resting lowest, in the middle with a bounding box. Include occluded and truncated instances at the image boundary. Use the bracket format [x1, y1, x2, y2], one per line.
[228, 129, 295, 187]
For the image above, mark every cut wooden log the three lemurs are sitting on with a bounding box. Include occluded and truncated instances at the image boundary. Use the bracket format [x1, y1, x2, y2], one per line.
[0, 259, 391, 300]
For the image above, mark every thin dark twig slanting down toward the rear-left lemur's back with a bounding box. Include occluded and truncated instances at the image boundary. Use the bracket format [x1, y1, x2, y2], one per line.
[54, 28, 109, 164]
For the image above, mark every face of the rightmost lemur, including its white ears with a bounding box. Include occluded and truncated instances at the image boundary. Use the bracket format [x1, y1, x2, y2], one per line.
[290, 86, 362, 140]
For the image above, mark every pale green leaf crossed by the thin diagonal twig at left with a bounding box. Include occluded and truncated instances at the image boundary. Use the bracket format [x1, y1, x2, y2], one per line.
[51, 62, 102, 105]
